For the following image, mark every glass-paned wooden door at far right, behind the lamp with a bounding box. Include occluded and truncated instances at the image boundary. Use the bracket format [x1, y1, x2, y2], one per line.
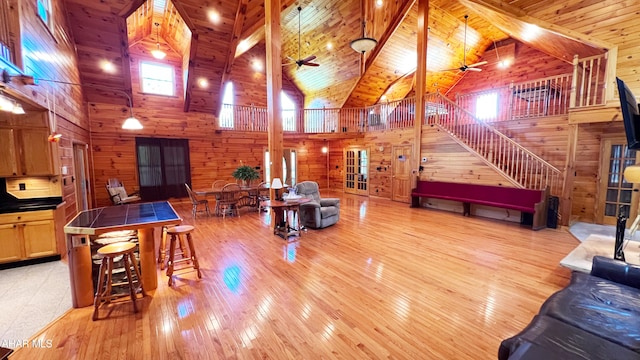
[596, 138, 638, 226]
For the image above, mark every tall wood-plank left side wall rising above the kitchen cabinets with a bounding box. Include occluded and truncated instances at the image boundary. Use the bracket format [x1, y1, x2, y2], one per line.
[6, 1, 89, 220]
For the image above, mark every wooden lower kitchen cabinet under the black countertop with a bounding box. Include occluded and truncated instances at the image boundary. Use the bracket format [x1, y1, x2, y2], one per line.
[0, 210, 60, 263]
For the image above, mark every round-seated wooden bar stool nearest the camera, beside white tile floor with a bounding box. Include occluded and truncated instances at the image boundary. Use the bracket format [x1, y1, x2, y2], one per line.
[93, 242, 147, 321]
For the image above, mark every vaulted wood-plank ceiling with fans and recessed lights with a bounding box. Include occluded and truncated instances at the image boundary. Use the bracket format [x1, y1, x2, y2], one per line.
[65, 0, 607, 114]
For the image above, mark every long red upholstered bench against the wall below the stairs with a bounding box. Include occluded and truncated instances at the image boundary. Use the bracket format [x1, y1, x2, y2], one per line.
[411, 180, 549, 230]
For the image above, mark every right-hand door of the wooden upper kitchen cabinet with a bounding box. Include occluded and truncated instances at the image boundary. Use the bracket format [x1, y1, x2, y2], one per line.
[18, 129, 53, 175]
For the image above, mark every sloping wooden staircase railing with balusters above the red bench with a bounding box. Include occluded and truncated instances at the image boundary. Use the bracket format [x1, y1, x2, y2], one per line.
[425, 93, 562, 195]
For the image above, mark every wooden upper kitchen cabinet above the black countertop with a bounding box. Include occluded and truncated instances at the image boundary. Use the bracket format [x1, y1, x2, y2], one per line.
[0, 128, 58, 177]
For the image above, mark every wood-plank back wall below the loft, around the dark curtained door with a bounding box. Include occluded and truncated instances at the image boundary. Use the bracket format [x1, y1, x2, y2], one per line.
[89, 103, 327, 206]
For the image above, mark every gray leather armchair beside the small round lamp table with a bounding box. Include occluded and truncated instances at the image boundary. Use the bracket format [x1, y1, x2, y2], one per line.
[295, 181, 340, 229]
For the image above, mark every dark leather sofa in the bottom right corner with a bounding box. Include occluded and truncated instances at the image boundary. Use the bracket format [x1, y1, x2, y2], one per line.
[498, 256, 640, 360]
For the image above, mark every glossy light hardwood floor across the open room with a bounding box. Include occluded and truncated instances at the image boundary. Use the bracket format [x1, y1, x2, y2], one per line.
[11, 194, 578, 360]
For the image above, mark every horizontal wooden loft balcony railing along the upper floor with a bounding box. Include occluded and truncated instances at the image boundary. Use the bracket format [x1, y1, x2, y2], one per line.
[218, 54, 610, 133]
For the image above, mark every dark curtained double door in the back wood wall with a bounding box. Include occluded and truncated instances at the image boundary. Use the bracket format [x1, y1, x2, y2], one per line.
[136, 138, 191, 201]
